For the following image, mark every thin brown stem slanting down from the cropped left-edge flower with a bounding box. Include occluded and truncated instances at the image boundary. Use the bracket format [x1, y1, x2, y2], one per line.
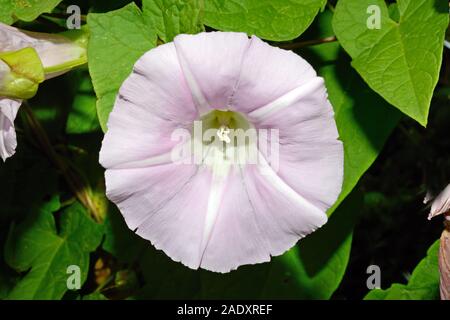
[22, 102, 101, 222]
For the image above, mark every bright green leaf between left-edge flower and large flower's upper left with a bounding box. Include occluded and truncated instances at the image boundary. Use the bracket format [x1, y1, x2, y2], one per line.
[88, 3, 156, 131]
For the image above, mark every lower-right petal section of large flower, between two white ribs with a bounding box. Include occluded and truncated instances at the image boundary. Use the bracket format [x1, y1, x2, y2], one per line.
[200, 156, 327, 272]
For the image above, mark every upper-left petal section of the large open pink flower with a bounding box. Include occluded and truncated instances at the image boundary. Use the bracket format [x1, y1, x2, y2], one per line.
[100, 43, 198, 168]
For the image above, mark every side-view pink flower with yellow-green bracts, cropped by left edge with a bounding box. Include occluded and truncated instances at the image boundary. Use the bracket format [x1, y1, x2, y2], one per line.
[0, 23, 87, 161]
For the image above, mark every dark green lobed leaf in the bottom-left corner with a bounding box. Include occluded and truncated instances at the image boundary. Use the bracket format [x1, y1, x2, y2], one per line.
[5, 201, 102, 299]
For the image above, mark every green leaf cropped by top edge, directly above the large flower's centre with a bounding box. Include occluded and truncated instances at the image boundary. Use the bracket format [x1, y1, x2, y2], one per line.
[205, 0, 326, 41]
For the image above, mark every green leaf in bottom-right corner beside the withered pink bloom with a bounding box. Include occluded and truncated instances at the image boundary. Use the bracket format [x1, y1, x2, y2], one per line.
[364, 240, 440, 300]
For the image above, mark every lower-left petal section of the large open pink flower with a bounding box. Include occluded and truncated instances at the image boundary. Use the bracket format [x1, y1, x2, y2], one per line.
[106, 164, 212, 269]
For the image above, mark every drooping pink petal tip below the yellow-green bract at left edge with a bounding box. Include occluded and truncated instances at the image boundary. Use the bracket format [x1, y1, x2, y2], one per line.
[0, 97, 22, 161]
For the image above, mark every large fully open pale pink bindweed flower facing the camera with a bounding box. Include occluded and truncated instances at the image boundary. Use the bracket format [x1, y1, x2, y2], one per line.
[100, 32, 343, 272]
